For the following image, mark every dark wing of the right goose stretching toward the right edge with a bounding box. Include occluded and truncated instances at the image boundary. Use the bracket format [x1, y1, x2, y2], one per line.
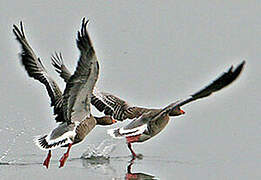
[167, 61, 245, 108]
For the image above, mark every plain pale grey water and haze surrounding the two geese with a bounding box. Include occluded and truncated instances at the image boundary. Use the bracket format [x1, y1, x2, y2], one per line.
[0, 0, 261, 179]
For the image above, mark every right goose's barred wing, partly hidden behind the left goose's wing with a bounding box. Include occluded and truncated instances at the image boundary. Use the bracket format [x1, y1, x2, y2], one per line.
[52, 53, 146, 121]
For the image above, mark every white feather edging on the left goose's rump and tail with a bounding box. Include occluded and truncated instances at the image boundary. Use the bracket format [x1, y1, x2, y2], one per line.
[34, 124, 78, 151]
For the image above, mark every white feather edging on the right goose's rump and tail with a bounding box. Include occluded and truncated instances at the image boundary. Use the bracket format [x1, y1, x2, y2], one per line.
[107, 124, 148, 139]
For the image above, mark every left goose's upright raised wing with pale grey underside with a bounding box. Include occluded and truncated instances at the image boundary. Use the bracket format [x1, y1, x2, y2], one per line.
[63, 18, 99, 122]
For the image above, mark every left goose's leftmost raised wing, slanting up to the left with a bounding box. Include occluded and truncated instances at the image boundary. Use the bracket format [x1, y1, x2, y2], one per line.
[13, 22, 63, 121]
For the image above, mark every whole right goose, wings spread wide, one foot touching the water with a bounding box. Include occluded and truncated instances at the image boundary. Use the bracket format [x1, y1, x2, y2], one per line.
[49, 50, 245, 158]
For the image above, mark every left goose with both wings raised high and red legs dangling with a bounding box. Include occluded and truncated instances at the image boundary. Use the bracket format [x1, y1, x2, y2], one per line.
[13, 18, 115, 168]
